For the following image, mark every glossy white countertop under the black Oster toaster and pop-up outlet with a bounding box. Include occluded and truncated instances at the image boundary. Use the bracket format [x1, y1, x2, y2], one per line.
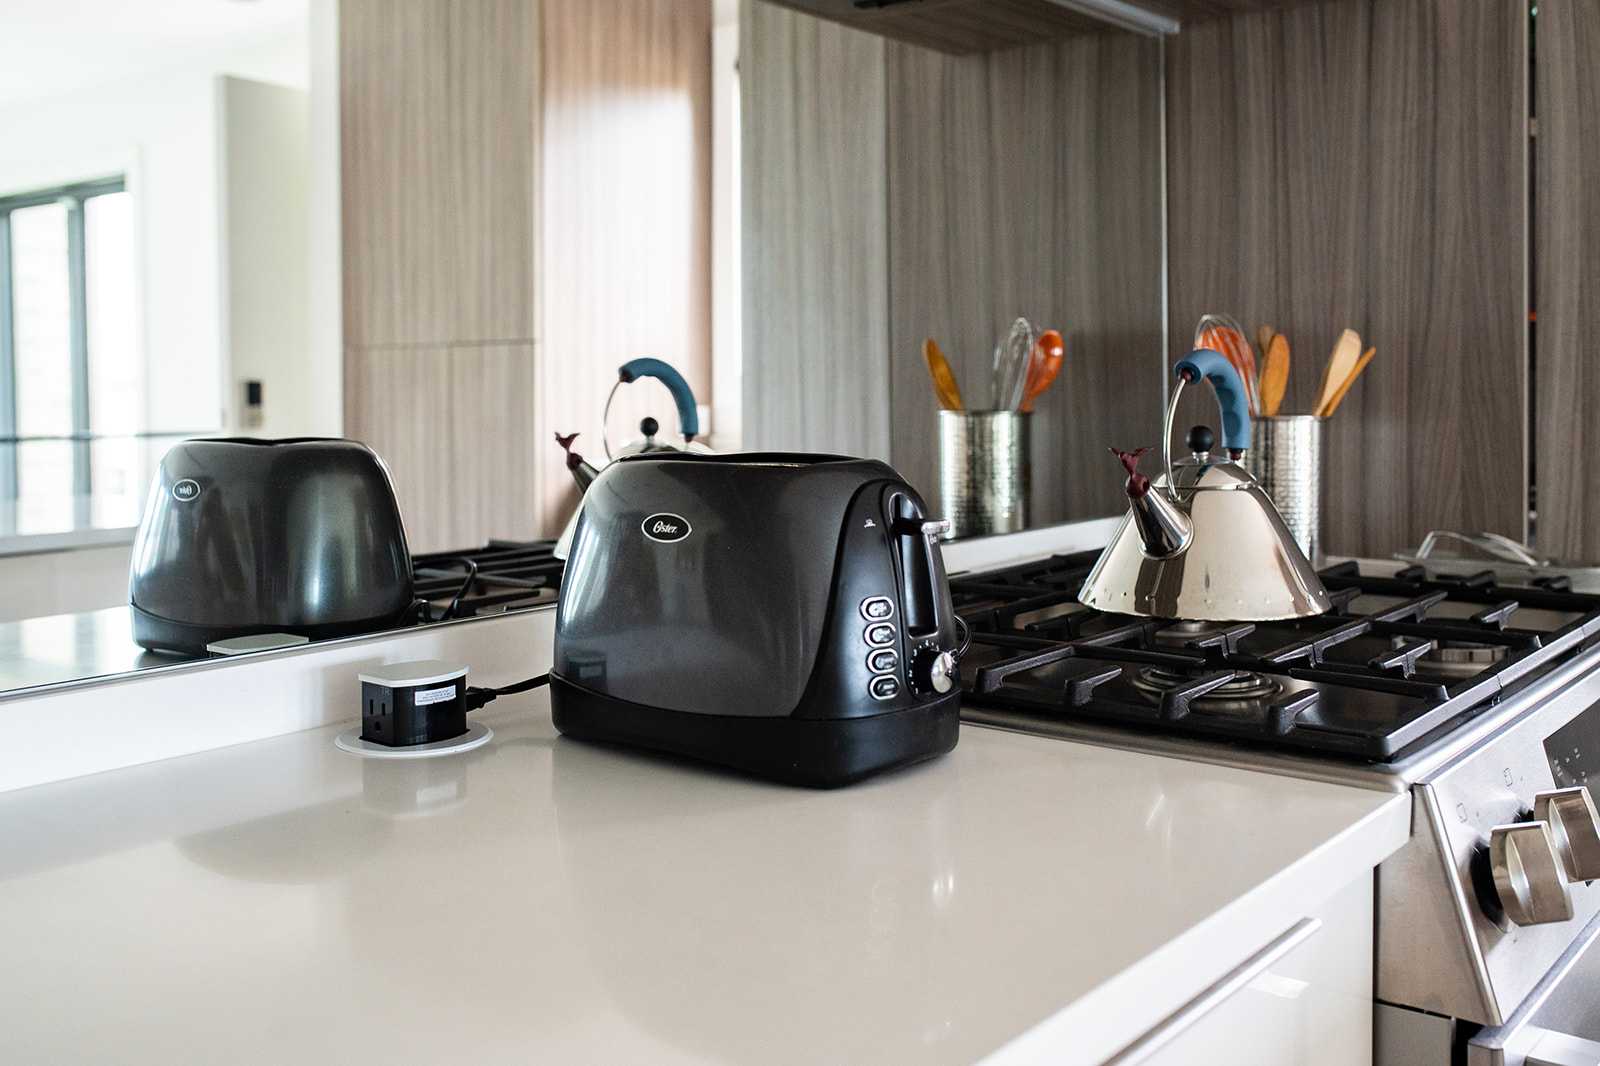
[0, 685, 1410, 1066]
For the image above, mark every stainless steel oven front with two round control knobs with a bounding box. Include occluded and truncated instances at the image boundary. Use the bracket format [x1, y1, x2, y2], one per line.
[1376, 653, 1600, 1066]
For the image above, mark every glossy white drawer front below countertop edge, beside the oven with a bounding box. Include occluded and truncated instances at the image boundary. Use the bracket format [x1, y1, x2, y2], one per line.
[1110, 877, 1373, 1066]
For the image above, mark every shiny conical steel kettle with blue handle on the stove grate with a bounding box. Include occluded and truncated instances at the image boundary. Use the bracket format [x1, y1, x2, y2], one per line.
[1078, 349, 1333, 621]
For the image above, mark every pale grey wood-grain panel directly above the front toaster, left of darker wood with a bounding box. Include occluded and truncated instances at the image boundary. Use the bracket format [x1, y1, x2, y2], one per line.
[739, 0, 890, 459]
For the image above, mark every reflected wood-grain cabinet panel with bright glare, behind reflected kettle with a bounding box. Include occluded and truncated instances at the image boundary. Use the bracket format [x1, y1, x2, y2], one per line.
[534, 0, 710, 536]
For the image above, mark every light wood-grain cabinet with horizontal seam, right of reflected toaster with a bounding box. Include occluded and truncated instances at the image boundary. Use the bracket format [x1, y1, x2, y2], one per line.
[339, 0, 539, 551]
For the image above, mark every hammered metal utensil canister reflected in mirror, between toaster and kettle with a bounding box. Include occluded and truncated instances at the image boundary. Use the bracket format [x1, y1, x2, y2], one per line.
[939, 411, 1032, 539]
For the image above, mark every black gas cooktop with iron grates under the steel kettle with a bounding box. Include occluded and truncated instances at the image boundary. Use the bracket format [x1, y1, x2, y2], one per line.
[950, 552, 1600, 763]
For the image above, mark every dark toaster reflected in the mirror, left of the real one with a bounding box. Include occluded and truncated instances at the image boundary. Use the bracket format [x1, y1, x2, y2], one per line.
[128, 437, 414, 655]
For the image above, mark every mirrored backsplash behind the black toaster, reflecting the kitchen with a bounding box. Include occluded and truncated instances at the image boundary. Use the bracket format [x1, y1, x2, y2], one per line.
[0, 0, 1163, 691]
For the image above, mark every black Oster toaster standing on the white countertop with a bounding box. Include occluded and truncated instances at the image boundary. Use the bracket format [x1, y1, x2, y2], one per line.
[550, 451, 960, 787]
